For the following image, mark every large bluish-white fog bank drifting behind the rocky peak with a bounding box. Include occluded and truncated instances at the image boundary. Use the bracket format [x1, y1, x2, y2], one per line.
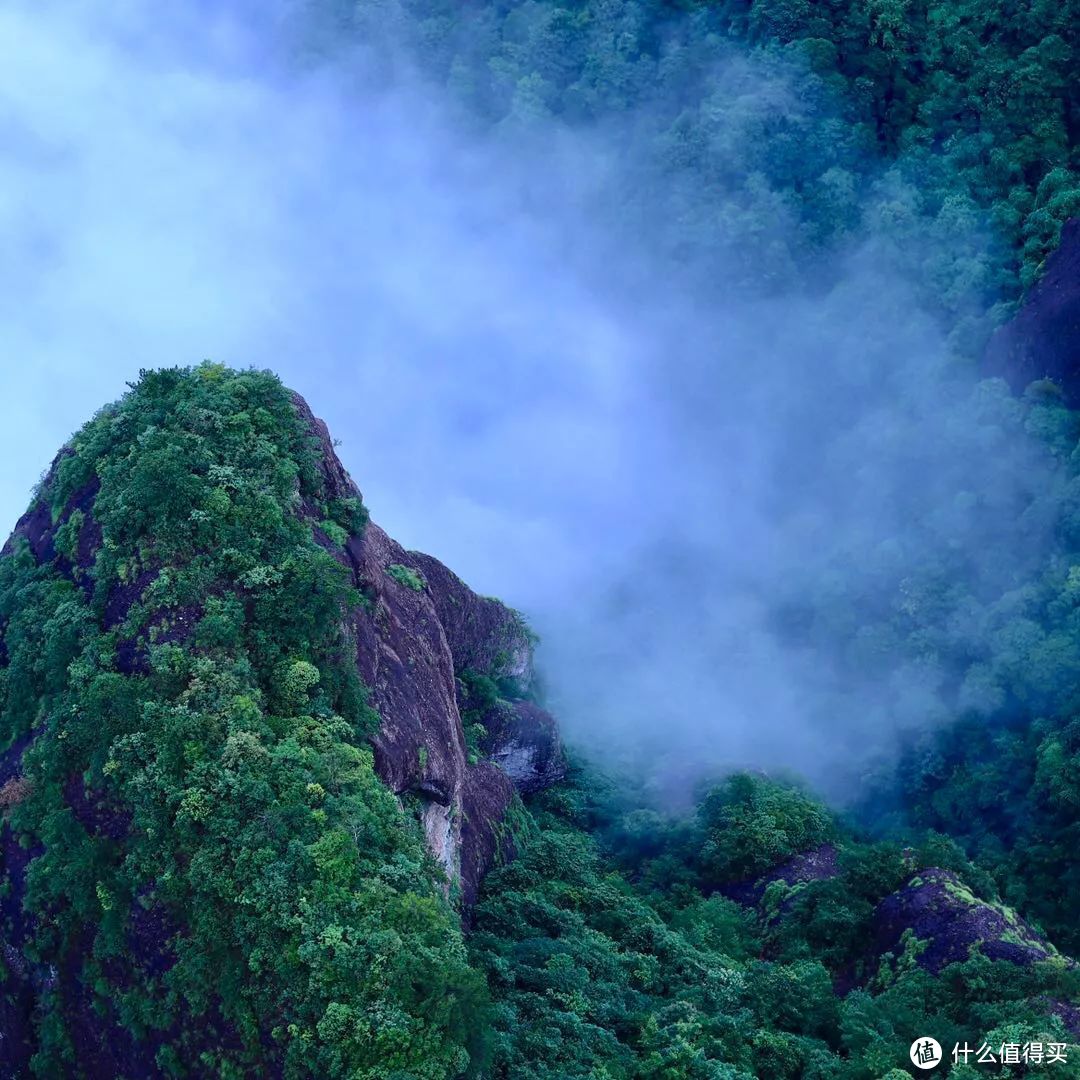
[0, 2, 1052, 794]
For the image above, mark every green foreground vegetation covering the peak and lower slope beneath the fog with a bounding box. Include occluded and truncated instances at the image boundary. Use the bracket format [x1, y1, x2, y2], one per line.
[0, 365, 1080, 1080]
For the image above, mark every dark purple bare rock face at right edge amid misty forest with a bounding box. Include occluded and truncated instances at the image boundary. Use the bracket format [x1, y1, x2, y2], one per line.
[983, 218, 1080, 407]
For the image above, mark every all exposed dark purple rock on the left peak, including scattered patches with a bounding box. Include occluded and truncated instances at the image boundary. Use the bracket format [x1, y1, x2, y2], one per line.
[0, 384, 563, 1080]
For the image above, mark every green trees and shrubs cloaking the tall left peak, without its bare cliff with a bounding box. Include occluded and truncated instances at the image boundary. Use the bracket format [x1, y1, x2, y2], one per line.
[0, 365, 482, 1080]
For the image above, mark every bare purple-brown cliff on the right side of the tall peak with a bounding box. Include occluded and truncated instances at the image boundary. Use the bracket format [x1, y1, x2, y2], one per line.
[295, 396, 564, 907]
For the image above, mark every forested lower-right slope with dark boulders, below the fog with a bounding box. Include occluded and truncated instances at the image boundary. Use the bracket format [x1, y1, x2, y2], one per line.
[470, 769, 1080, 1080]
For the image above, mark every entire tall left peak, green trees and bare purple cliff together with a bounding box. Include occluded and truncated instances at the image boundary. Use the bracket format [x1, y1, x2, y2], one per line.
[0, 365, 562, 1080]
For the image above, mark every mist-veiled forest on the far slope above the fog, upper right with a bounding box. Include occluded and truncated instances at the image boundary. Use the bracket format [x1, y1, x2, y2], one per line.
[324, 0, 1080, 332]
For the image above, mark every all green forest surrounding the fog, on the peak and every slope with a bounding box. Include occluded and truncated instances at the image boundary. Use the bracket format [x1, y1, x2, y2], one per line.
[6, 0, 1080, 1080]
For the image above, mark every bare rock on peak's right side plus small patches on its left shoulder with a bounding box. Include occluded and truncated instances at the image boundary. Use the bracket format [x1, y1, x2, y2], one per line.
[0, 394, 563, 906]
